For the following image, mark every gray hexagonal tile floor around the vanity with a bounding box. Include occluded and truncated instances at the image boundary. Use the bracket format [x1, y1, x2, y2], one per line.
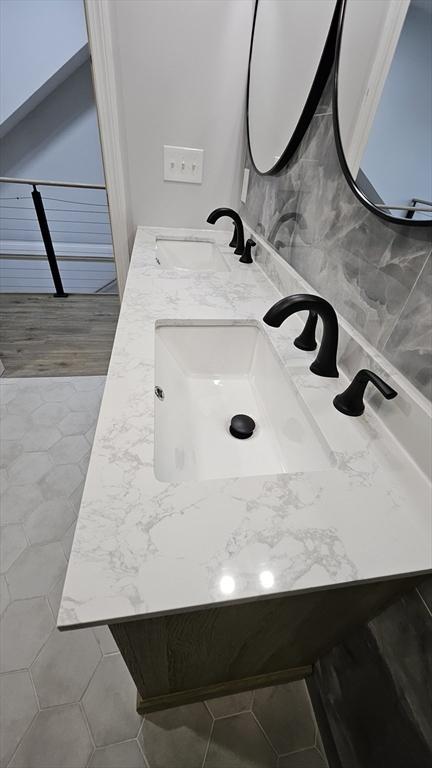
[0, 376, 326, 768]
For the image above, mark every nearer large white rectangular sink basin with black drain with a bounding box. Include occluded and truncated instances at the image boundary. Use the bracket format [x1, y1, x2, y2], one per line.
[154, 323, 334, 482]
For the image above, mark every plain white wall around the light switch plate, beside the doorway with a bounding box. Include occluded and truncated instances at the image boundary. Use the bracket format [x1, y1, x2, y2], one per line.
[110, 0, 253, 234]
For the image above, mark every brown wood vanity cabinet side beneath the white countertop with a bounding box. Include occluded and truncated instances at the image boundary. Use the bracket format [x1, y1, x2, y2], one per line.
[110, 577, 421, 715]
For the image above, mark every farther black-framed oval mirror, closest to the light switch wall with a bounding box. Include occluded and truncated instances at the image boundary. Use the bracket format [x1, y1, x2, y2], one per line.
[247, 0, 337, 174]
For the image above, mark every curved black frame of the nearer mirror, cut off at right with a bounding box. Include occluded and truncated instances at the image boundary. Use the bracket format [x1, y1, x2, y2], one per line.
[333, 0, 432, 227]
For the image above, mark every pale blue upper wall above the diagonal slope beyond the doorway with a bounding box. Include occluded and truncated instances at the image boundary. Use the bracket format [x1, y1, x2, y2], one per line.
[0, 0, 87, 123]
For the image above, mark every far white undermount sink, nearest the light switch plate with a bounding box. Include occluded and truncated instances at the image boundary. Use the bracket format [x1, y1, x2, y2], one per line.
[156, 238, 229, 272]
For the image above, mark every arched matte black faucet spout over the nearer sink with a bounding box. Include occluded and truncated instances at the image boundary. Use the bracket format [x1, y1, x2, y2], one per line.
[263, 293, 339, 378]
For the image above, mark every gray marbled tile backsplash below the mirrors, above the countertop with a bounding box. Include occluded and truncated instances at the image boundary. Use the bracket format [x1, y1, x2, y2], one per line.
[241, 79, 432, 399]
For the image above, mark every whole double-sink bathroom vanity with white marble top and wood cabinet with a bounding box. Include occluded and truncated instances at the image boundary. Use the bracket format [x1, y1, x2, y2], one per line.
[58, 227, 432, 713]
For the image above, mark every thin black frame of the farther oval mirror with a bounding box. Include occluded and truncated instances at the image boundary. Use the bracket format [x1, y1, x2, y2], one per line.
[246, 0, 343, 176]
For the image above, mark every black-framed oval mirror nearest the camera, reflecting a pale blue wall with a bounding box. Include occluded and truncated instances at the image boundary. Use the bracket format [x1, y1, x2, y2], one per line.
[333, 0, 432, 225]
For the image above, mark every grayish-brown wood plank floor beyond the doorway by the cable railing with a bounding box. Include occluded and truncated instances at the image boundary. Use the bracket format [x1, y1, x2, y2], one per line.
[0, 293, 120, 377]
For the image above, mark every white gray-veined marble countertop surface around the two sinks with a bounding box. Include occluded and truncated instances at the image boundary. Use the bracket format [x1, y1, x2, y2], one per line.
[58, 227, 432, 629]
